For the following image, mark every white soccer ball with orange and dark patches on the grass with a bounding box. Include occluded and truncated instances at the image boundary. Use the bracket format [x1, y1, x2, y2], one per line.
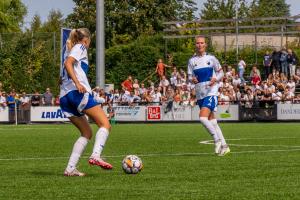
[122, 155, 143, 174]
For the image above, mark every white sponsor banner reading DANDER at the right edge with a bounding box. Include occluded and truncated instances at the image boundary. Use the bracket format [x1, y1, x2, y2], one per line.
[277, 104, 300, 120]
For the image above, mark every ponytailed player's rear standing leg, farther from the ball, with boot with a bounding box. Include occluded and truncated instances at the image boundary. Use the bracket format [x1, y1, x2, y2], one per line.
[64, 116, 92, 176]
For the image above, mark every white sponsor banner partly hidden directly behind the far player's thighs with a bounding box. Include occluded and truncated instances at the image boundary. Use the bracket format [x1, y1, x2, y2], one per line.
[192, 105, 239, 121]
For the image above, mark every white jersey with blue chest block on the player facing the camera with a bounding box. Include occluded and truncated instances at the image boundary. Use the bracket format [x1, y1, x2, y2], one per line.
[188, 54, 222, 100]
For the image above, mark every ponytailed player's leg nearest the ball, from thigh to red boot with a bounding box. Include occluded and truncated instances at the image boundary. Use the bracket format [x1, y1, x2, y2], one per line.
[84, 105, 112, 169]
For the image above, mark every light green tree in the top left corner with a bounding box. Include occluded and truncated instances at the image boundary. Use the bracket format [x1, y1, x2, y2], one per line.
[0, 0, 27, 32]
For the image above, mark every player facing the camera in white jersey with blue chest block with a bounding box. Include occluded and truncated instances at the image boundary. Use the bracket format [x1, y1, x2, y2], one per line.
[188, 36, 230, 156]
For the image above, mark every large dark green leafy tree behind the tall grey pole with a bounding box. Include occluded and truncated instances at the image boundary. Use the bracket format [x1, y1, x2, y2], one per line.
[67, 0, 196, 48]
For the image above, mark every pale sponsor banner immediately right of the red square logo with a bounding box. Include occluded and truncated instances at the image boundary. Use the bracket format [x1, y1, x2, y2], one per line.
[161, 106, 191, 121]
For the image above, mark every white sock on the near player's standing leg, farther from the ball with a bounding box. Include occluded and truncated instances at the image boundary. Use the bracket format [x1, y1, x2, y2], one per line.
[67, 136, 89, 172]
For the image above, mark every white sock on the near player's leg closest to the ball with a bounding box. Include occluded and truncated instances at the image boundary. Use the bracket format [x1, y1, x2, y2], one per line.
[91, 128, 109, 158]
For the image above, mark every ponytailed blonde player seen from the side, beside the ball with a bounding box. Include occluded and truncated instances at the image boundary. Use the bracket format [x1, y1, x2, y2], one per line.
[60, 28, 112, 176]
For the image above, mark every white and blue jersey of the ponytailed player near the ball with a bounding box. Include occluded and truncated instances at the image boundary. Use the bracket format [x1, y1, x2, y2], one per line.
[60, 44, 92, 98]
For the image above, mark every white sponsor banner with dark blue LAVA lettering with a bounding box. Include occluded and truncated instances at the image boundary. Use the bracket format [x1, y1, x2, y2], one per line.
[30, 106, 69, 122]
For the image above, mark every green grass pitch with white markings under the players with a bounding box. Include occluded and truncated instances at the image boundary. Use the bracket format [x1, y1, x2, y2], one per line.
[0, 123, 300, 200]
